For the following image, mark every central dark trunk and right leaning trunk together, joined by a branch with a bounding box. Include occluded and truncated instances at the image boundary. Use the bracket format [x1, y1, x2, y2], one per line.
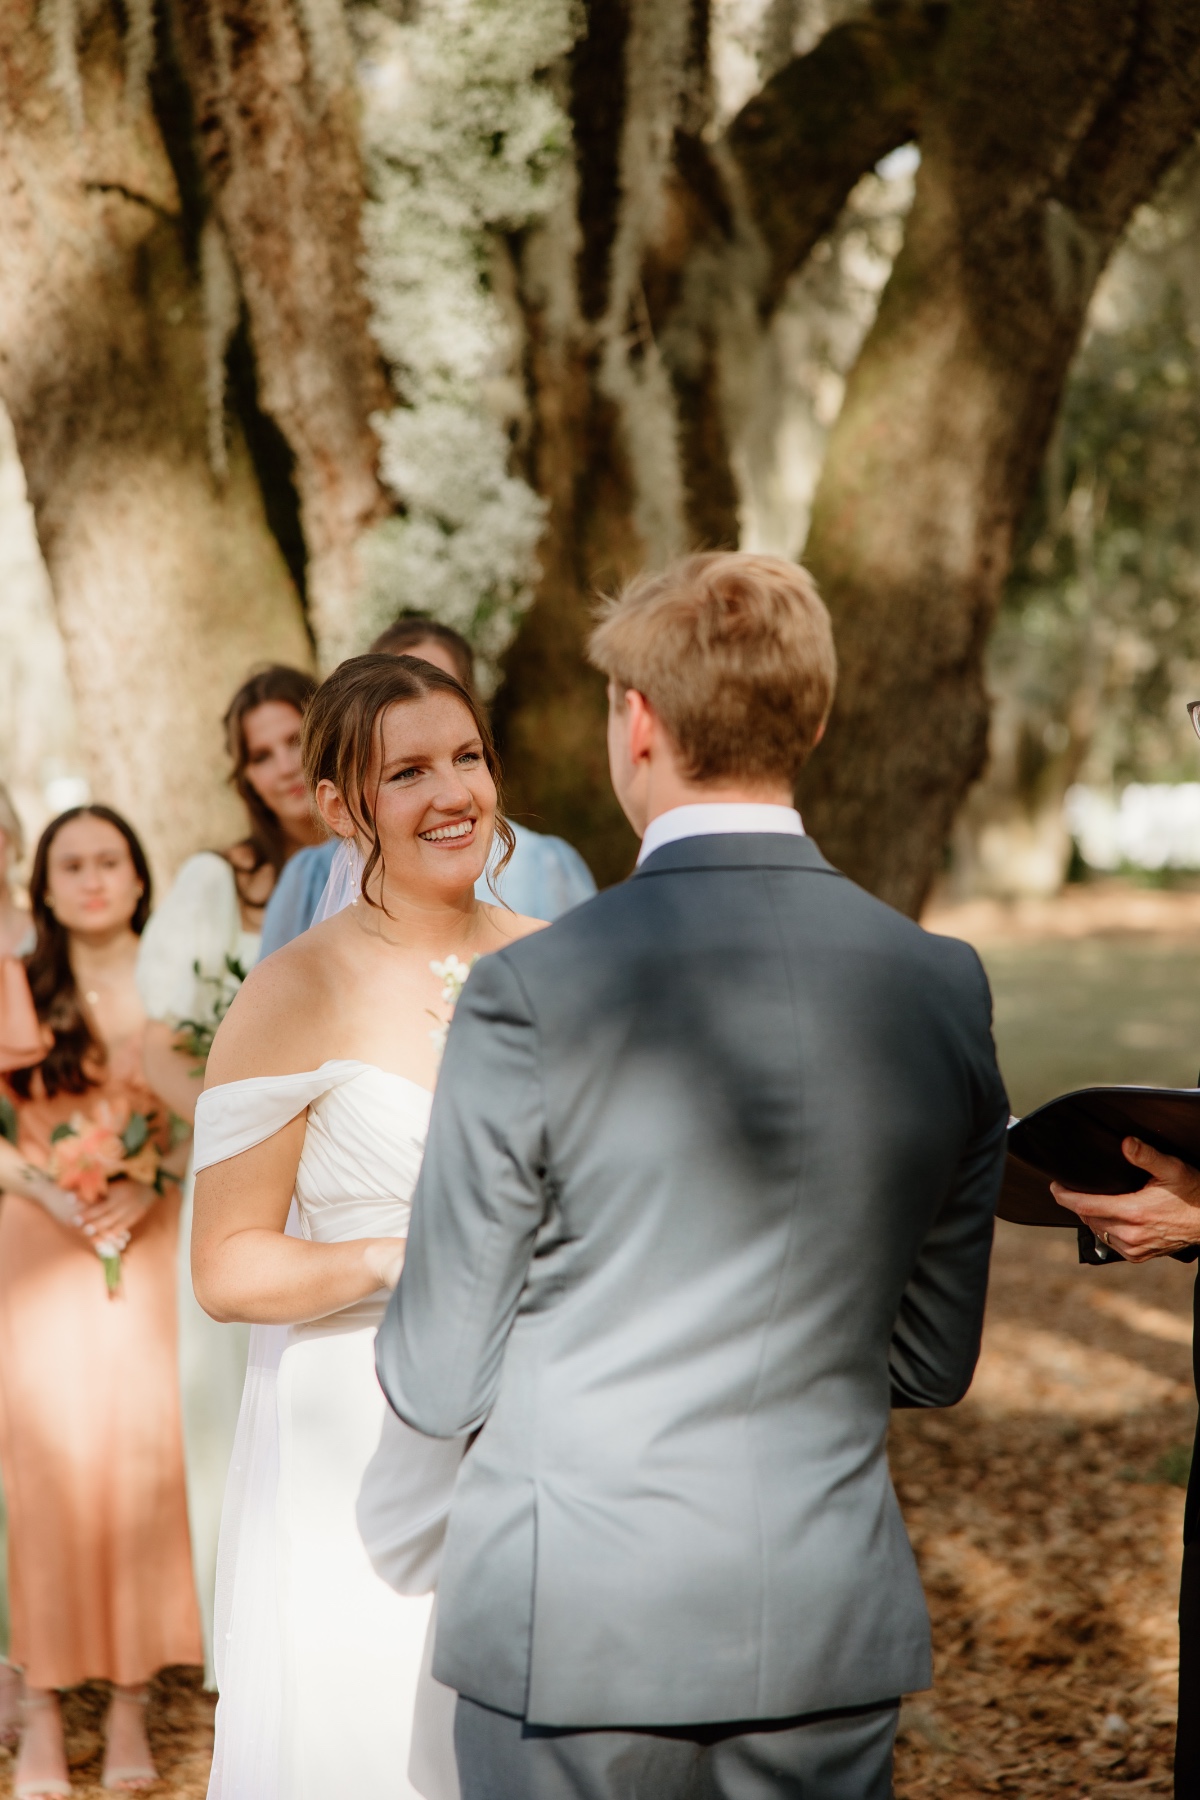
[500, 0, 1200, 913]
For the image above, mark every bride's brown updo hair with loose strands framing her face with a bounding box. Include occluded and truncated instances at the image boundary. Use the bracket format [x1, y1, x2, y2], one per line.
[300, 655, 516, 911]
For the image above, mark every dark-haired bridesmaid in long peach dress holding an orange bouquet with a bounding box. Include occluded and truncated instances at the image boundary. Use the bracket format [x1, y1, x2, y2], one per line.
[0, 806, 201, 1796]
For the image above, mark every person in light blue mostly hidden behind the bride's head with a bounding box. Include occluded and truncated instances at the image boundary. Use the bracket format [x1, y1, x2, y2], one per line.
[263, 612, 596, 956]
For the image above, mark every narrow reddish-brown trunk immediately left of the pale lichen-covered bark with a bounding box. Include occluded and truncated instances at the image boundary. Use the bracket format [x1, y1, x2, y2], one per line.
[173, 0, 392, 668]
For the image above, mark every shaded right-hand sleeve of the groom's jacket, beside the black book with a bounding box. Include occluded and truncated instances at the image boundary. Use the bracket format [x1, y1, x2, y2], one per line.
[889, 952, 1009, 1408]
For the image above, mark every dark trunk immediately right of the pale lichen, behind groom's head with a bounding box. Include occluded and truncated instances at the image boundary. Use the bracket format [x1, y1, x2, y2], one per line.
[495, 0, 687, 882]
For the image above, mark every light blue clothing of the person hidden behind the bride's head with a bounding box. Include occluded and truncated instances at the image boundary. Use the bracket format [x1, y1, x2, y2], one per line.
[261, 824, 596, 956]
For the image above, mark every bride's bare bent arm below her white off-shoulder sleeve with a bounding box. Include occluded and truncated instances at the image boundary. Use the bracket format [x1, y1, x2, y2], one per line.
[193, 1112, 405, 1325]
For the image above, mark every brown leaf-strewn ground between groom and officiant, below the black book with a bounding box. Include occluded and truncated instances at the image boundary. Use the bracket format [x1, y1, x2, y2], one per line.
[892, 1226, 1195, 1800]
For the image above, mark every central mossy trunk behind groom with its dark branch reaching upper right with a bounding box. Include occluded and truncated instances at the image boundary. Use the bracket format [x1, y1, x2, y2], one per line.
[497, 0, 937, 880]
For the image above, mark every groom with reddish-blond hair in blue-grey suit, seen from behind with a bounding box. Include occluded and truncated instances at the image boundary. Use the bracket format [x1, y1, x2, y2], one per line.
[378, 553, 1007, 1800]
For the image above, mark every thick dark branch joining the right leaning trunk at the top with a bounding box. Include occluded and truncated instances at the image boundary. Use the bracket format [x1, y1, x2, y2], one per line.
[725, 5, 946, 311]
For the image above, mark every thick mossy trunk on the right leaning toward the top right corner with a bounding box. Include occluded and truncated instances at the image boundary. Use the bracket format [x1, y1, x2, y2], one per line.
[802, 0, 1200, 913]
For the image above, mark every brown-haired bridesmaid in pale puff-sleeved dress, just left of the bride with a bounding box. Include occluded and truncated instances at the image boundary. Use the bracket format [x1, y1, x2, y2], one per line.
[137, 664, 324, 1681]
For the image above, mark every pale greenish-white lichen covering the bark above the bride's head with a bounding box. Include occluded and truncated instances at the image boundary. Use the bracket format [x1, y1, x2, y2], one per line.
[353, 0, 578, 668]
